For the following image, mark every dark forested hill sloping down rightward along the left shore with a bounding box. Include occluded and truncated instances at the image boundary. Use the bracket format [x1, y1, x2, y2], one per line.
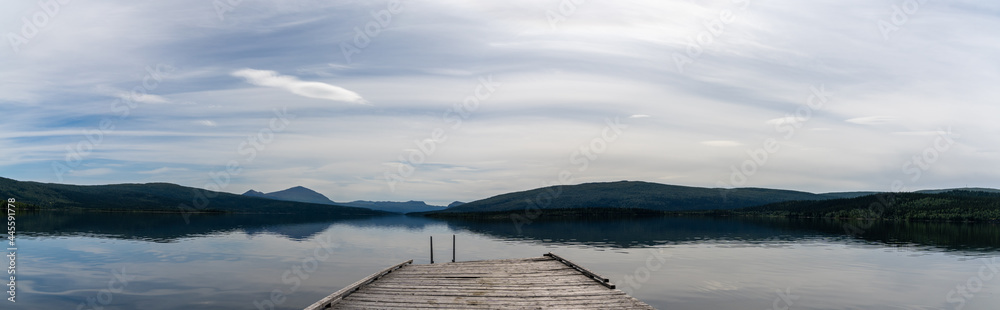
[0, 178, 385, 216]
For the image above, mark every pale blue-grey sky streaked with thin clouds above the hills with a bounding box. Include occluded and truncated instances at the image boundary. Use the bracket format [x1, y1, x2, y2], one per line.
[0, 0, 1000, 204]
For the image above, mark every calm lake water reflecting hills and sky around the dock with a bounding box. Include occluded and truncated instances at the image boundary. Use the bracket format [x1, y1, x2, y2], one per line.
[9, 213, 1000, 310]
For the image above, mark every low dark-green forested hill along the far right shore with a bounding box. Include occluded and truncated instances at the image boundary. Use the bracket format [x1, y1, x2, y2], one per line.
[728, 190, 1000, 221]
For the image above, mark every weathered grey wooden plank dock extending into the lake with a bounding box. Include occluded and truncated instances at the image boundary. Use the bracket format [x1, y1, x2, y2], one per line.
[306, 253, 653, 310]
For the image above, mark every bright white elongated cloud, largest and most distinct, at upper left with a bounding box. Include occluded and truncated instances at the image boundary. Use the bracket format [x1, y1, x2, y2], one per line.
[232, 68, 368, 104]
